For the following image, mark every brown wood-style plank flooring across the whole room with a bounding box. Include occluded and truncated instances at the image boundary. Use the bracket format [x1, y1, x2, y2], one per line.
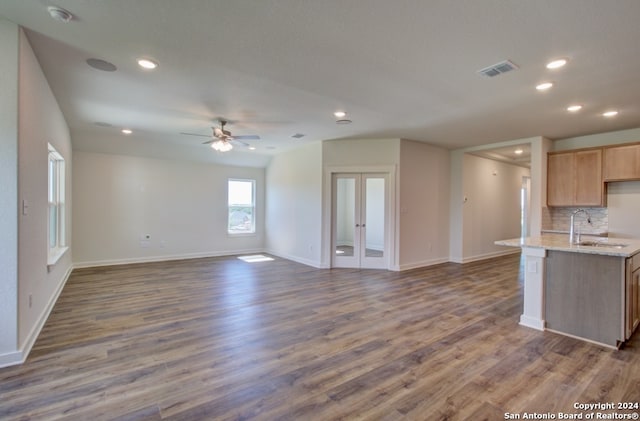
[0, 255, 640, 421]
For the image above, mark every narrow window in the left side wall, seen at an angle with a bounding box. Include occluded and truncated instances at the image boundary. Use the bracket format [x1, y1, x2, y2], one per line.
[48, 145, 66, 264]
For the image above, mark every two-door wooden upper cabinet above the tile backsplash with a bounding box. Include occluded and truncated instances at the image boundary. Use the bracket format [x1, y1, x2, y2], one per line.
[547, 148, 606, 206]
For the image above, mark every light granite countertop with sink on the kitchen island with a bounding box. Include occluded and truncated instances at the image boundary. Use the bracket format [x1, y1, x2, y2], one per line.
[495, 234, 640, 257]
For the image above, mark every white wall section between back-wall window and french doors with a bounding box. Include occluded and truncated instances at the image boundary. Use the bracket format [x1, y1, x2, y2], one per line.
[266, 143, 322, 267]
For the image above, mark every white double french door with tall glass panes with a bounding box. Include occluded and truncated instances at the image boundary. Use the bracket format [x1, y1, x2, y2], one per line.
[332, 173, 389, 269]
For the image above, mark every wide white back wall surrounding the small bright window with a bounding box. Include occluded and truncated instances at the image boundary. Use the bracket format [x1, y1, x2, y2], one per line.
[73, 151, 265, 267]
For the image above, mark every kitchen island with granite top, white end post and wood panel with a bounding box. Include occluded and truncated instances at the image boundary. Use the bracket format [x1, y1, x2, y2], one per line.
[495, 234, 640, 348]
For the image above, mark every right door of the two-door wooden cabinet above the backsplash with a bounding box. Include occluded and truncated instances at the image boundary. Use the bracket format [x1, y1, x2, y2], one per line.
[574, 149, 604, 206]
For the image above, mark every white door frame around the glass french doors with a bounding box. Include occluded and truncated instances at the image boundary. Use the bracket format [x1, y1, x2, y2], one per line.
[321, 165, 400, 271]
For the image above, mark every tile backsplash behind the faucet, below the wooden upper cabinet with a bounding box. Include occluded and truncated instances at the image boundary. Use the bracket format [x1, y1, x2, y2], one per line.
[542, 207, 609, 234]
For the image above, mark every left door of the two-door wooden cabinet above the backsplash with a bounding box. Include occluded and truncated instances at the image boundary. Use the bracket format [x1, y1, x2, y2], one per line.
[547, 152, 575, 206]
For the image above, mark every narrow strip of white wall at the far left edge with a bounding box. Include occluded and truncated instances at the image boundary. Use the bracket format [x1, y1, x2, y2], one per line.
[0, 18, 20, 367]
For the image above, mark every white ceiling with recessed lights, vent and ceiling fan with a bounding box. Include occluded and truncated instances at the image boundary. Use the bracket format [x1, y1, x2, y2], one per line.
[0, 0, 640, 165]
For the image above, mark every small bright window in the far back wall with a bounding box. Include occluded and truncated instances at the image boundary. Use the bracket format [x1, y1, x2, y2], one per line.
[227, 178, 256, 234]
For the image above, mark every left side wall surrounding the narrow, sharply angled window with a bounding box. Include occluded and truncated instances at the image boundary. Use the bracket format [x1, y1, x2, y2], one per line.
[12, 28, 73, 364]
